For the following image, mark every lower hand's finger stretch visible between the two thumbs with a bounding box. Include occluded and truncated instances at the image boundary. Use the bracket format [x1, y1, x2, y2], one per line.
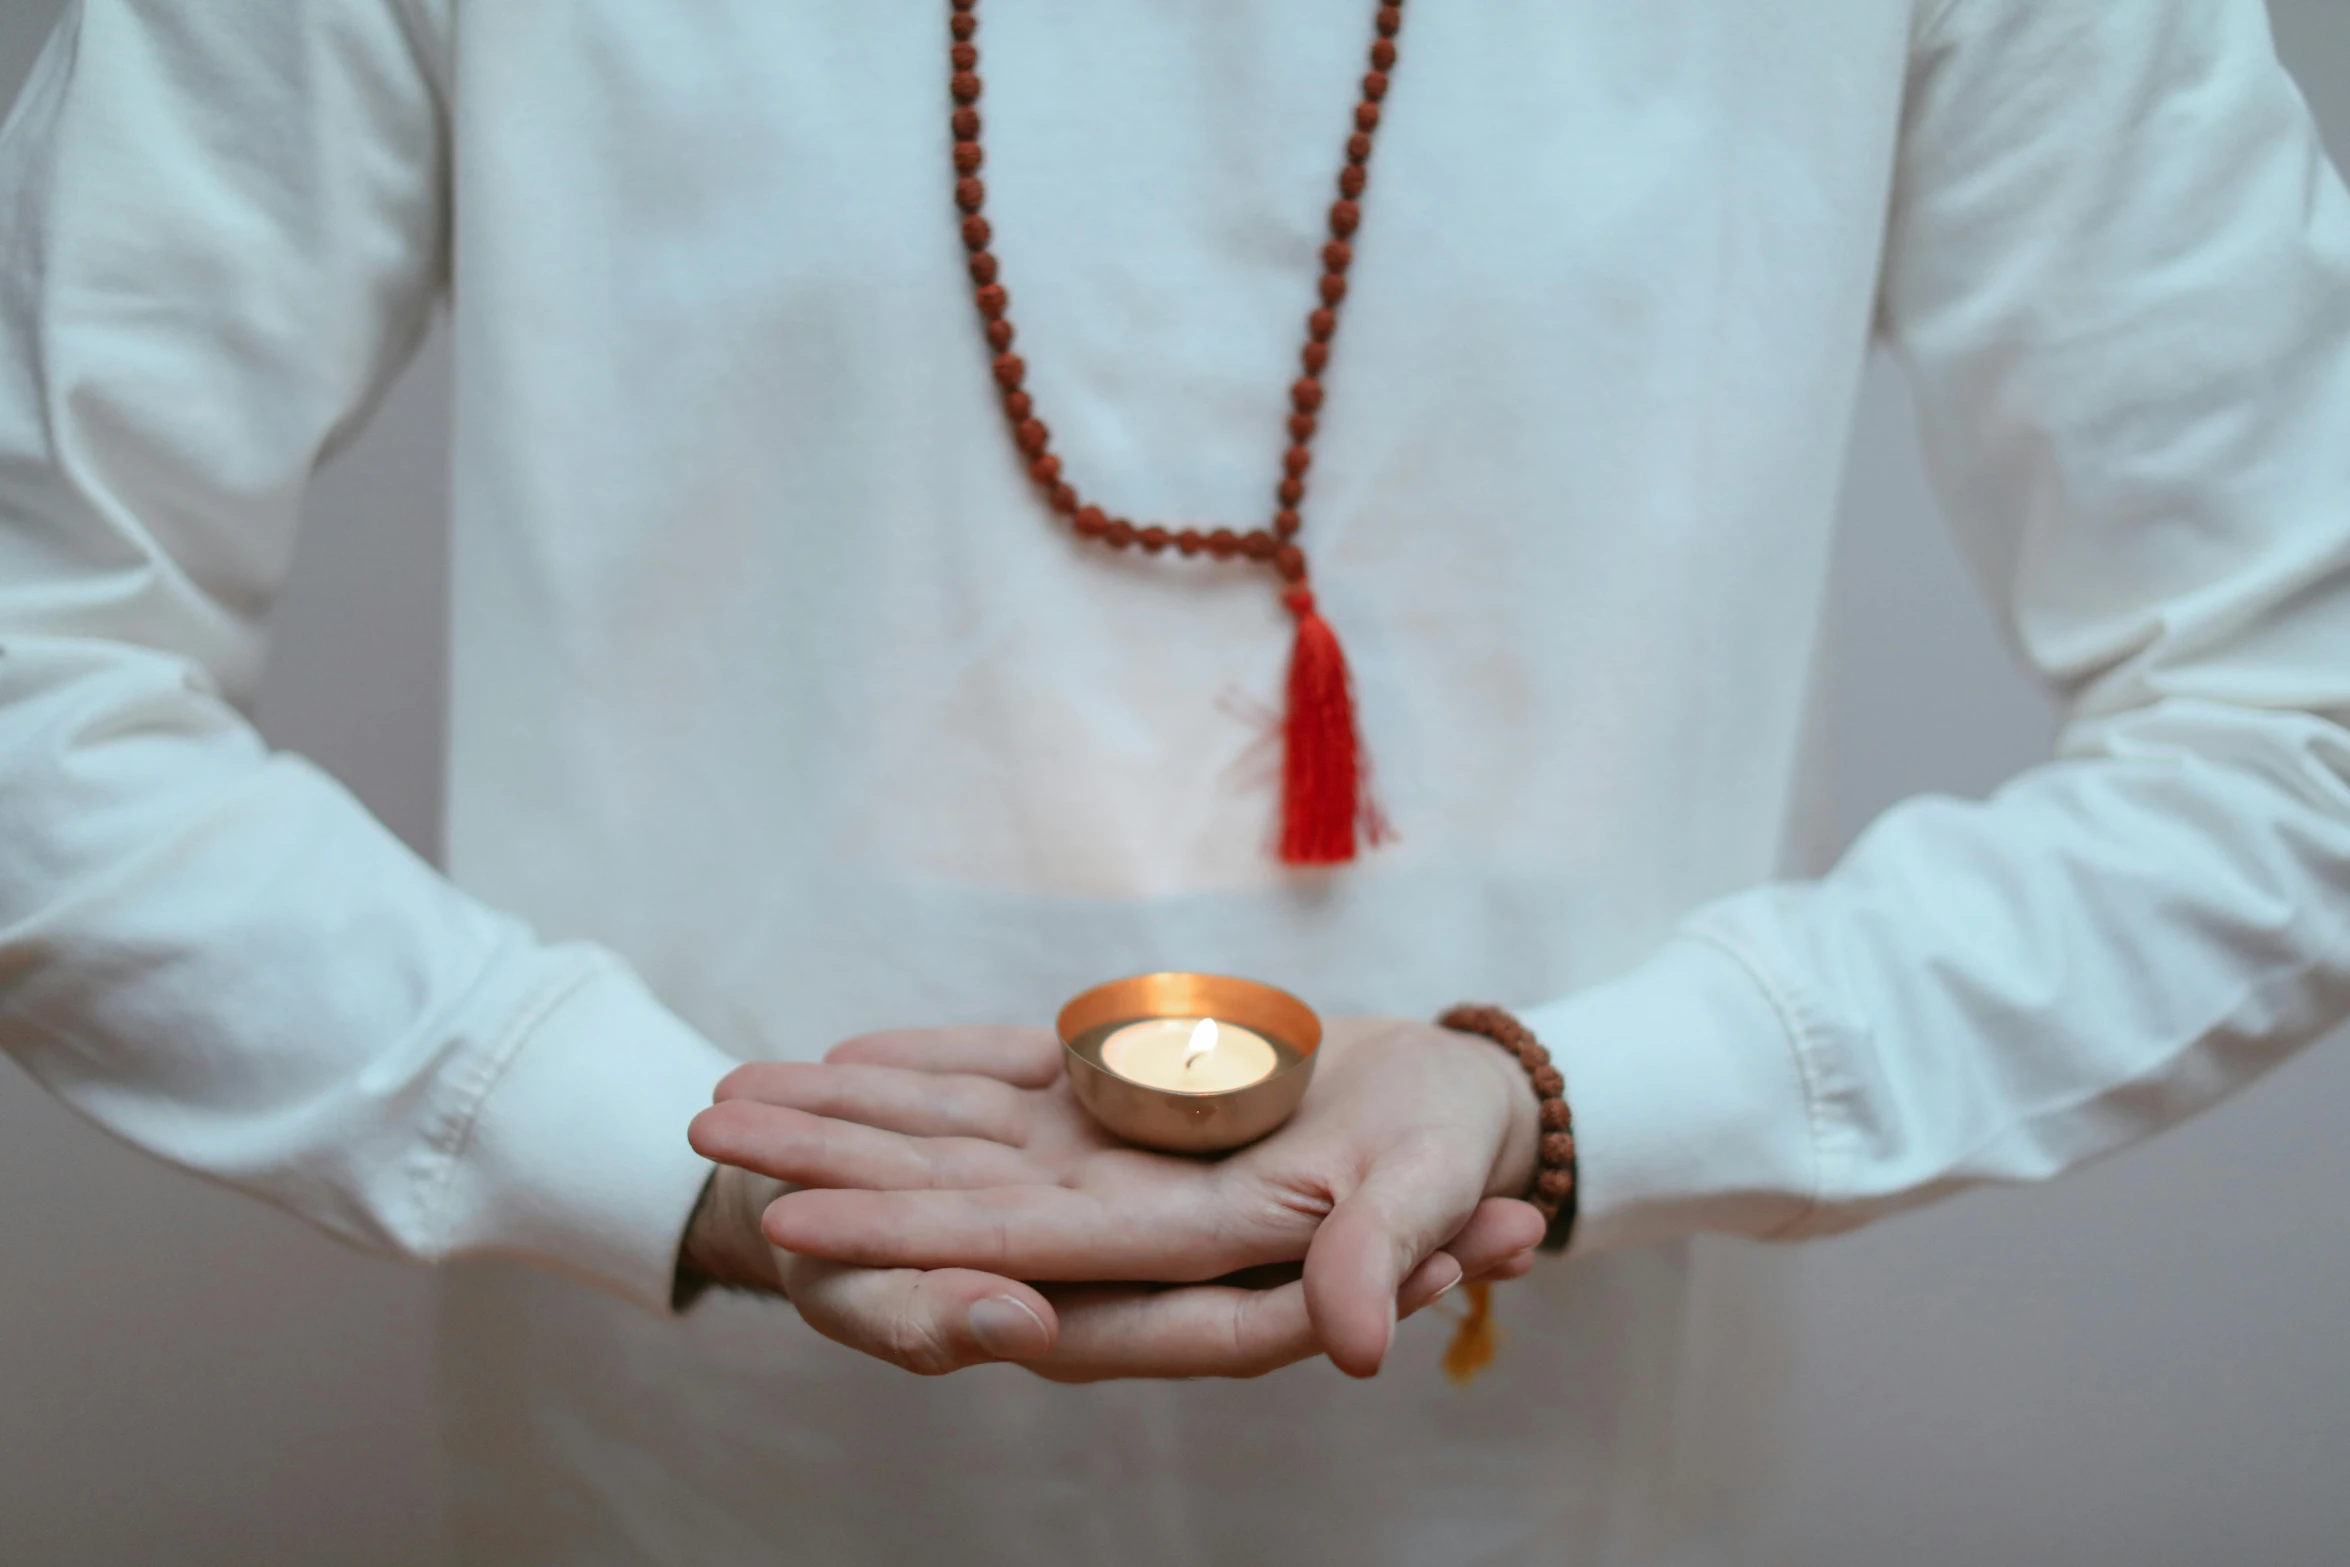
[1027, 1283, 1321, 1381]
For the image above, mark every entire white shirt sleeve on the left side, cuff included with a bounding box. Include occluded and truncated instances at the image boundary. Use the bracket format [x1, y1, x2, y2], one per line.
[0, 0, 729, 1309]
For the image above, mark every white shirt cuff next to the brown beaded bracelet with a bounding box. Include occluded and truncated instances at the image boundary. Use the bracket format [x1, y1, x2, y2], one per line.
[1518, 935, 1821, 1257]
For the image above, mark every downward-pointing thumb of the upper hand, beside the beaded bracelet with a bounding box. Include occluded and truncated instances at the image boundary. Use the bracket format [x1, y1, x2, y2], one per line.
[1304, 1158, 1478, 1377]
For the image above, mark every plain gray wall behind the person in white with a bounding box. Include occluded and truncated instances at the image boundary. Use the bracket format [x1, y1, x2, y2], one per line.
[0, 0, 2350, 1567]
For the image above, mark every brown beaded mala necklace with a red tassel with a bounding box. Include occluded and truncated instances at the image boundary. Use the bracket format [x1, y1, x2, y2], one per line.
[947, 0, 1403, 865]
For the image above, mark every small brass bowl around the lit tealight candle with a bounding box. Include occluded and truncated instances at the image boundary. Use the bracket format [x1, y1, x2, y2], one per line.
[1058, 973, 1321, 1154]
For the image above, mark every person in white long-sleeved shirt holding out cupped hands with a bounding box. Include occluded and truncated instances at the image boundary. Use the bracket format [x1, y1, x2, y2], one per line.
[0, 0, 2350, 1565]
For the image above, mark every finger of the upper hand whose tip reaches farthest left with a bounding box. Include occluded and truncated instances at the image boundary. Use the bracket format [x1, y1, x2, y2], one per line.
[686, 1099, 1039, 1191]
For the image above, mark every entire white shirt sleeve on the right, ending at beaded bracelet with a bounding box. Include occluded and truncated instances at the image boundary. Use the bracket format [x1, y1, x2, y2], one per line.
[1530, 0, 2350, 1250]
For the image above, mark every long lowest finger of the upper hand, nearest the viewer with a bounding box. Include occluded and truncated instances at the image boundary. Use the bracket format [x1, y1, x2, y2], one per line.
[766, 1174, 1287, 1290]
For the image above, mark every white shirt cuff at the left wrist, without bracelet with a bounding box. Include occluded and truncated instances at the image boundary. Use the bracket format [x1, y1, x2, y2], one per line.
[442, 949, 738, 1313]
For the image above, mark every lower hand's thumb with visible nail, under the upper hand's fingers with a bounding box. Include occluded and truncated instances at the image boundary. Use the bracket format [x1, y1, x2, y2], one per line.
[783, 1257, 1060, 1377]
